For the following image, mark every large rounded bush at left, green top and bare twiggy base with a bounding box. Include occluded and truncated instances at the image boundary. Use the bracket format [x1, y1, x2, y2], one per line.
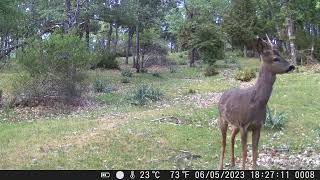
[13, 34, 93, 105]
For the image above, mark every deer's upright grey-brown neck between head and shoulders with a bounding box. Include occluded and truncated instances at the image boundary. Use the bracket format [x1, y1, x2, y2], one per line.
[254, 64, 276, 106]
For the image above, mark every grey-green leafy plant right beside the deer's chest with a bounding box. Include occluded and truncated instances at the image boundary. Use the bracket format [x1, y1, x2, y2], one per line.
[264, 106, 286, 130]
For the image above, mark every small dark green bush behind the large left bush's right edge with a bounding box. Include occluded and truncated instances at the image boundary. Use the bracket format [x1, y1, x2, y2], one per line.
[95, 50, 119, 69]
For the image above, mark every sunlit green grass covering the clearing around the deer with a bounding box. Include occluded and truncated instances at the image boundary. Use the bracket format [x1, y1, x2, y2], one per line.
[0, 54, 320, 169]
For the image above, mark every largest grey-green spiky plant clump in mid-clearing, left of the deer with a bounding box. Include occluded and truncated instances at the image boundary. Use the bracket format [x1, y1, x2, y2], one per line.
[132, 85, 163, 106]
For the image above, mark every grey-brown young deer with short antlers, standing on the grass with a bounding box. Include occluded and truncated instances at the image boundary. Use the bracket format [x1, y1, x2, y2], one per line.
[218, 35, 295, 170]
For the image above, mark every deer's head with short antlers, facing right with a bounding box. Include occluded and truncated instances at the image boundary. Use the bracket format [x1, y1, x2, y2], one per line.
[257, 36, 295, 74]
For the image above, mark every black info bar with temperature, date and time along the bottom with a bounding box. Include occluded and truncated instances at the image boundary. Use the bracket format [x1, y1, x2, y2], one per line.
[0, 170, 320, 180]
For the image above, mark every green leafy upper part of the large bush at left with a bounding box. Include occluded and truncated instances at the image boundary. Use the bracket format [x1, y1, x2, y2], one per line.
[17, 34, 91, 77]
